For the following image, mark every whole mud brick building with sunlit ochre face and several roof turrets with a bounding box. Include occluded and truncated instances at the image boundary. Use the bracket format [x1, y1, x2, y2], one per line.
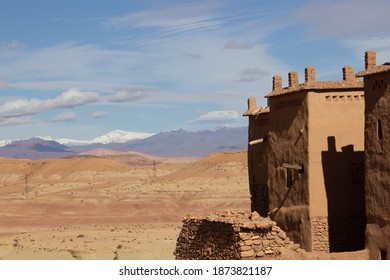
[244, 66, 366, 252]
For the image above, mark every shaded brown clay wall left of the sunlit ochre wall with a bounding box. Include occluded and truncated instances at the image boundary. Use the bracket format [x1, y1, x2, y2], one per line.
[268, 91, 311, 251]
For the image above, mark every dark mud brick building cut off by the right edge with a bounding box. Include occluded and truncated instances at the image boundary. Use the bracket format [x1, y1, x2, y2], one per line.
[358, 50, 390, 259]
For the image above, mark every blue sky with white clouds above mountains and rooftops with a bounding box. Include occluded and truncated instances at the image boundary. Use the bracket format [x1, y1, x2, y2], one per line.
[0, 0, 390, 140]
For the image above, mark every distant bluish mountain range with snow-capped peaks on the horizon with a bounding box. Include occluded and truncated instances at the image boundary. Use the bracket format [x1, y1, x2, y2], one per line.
[0, 127, 248, 159]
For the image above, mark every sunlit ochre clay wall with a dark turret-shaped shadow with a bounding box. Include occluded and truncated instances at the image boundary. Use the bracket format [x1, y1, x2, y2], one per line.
[308, 89, 366, 252]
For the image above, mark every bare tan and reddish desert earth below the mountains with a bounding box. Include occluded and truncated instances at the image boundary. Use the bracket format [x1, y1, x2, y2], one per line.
[0, 152, 366, 260]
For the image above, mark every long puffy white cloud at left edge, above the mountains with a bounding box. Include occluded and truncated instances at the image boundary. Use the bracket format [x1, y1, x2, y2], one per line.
[0, 89, 100, 118]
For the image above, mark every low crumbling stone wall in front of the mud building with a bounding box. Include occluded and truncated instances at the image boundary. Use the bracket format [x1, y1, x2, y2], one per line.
[174, 211, 304, 260]
